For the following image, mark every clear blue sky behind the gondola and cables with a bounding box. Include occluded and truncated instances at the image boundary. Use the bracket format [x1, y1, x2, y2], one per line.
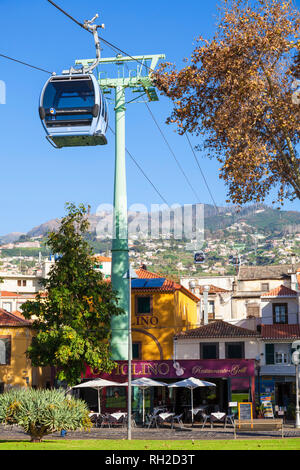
[0, 0, 300, 235]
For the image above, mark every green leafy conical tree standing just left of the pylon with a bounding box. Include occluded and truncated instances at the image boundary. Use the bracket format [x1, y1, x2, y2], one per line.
[22, 204, 124, 385]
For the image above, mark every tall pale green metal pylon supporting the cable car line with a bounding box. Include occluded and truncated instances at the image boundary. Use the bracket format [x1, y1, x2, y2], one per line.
[76, 54, 165, 360]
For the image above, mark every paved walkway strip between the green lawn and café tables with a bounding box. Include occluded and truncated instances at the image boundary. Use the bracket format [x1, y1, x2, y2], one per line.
[0, 424, 300, 441]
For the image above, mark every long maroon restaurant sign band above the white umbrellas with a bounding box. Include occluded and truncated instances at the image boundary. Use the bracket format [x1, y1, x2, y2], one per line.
[85, 359, 255, 380]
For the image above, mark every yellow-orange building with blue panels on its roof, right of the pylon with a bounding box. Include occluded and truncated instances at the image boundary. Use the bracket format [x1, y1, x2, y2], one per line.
[131, 268, 200, 360]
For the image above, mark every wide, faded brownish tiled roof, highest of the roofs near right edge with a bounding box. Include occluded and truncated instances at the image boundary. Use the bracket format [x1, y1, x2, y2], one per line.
[238, 264, 295, 281]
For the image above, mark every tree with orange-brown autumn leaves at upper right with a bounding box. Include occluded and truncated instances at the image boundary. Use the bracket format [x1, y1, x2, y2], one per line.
[155, 0, 300, 204]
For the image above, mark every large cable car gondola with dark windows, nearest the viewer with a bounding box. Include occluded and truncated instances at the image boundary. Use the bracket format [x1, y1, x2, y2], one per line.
[39, 71, 108, 148]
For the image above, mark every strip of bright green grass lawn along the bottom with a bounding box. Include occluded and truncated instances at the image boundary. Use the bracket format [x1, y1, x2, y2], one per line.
[0, 438, 300, 451]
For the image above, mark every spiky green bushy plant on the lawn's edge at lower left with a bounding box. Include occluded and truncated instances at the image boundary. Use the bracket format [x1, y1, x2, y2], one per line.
[0, 389, 92, 442]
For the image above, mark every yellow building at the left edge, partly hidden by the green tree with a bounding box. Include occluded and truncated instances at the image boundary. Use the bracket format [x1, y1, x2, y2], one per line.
[0, 309, 51, 393]
